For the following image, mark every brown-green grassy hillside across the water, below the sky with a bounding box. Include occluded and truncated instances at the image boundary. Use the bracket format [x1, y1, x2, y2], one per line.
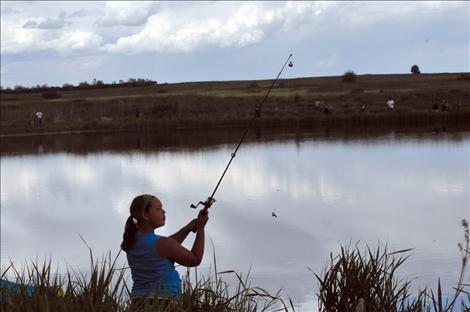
[1, 73, 470, 136]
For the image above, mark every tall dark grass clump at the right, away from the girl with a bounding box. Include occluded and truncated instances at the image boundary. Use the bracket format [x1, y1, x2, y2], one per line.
[314, 220, 470, 312]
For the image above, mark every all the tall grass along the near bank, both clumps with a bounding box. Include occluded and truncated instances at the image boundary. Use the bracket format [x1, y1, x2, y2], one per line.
[0, 220, 470, 312]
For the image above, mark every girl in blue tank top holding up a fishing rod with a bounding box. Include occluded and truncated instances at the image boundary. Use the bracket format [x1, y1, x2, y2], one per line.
[121, 194, 214, 298]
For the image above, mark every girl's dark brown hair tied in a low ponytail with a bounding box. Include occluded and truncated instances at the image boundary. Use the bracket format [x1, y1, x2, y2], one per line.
[121, 195, 154, 251]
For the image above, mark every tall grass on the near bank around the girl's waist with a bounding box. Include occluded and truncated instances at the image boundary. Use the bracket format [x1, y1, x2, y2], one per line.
[0, 247, 292, 312]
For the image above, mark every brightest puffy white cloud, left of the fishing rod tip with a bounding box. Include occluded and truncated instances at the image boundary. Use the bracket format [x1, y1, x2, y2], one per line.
[104, 4, 282, 54]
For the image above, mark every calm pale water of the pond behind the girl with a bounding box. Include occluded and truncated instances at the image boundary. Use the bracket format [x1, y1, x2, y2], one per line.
[1, 132, 470, 311]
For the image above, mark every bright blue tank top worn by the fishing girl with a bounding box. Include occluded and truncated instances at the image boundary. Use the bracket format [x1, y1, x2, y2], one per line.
[127, 233, 181, 297]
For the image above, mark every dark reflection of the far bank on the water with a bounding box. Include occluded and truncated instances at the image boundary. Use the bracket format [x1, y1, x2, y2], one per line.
[1, 125, 470, 155]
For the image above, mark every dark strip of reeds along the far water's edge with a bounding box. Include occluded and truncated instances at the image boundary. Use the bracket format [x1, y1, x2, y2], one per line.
[0, 113, 470, 138]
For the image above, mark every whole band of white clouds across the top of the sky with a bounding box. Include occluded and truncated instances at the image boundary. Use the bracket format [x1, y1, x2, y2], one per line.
[2, 1, 468, 54]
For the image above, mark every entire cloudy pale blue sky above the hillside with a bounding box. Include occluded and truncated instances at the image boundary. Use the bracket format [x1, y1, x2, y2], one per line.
[0, 1, 470, 87]
